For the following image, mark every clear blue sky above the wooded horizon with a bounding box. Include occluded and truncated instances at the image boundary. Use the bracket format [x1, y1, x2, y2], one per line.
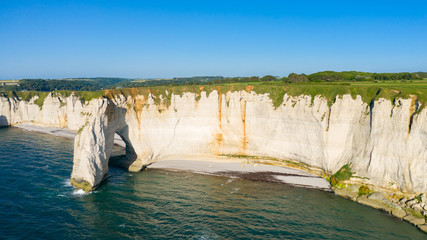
[0, 0, 427, 79]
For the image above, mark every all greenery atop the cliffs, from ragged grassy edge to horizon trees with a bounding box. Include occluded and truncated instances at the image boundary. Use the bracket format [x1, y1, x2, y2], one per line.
[0, 71, 427, 108]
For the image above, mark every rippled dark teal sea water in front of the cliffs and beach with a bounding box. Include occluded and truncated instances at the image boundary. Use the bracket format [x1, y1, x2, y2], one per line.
[0, 128, 427, 239]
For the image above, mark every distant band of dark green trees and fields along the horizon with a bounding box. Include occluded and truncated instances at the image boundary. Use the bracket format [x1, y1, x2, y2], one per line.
[0, 71, 427, 92]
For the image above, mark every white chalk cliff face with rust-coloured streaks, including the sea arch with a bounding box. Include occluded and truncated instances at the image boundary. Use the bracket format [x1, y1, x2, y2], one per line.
[0, 91, 427, 193]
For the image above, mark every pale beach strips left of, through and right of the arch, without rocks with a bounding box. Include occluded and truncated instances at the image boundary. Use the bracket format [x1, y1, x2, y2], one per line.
[12, 123, 332, 192]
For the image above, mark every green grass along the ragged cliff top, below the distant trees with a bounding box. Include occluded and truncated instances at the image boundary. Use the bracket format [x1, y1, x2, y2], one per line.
[4, 79, 427, 107]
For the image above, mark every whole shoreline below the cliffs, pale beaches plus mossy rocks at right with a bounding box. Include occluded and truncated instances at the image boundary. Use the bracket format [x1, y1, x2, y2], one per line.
[6, 123, 427, 233]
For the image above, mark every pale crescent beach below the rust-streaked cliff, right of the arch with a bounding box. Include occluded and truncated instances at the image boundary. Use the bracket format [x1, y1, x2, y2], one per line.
[147, 160, 332, 191]
